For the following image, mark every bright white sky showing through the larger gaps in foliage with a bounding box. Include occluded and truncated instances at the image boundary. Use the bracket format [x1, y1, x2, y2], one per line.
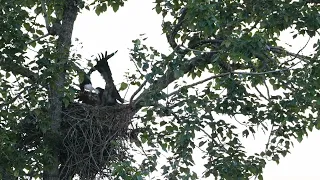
[73, 0, 320, 180]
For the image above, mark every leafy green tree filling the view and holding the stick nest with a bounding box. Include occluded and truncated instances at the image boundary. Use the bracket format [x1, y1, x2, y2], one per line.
[0, 0, 320, 180]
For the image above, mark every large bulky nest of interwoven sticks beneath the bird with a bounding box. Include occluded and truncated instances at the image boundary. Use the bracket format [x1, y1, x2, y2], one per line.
[60, 103, 135, 179]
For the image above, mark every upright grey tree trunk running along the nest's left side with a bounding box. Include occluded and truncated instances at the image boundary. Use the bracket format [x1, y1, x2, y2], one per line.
[43, 0, 79, 180]
